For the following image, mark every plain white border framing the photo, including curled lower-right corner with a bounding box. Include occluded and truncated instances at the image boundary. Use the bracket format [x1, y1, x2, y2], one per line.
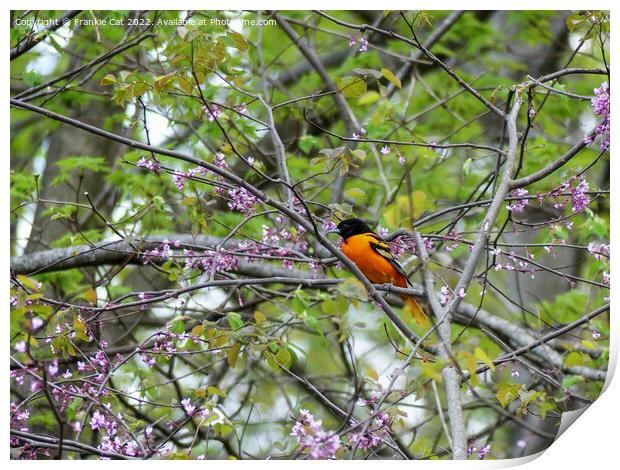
[0, 0, 620, 470]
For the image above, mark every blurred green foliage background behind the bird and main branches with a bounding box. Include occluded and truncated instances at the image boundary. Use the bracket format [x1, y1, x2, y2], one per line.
[10, 11, 609, 459]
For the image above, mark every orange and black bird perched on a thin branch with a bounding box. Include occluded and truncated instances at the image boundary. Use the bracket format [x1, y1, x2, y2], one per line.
[329, 219, 428, 326]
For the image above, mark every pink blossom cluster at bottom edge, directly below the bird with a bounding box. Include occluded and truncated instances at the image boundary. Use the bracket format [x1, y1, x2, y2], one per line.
[291, 410, 340, 460]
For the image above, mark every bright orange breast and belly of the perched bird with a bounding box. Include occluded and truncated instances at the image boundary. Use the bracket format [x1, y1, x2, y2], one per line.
[341, 234, 407, 287]
